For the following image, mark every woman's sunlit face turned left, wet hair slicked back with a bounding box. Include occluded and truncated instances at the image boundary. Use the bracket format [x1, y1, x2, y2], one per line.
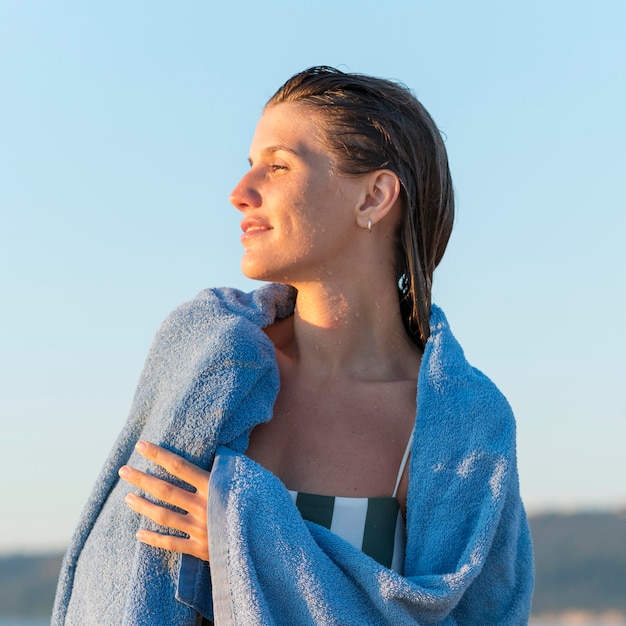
[230, 103, 365, 284]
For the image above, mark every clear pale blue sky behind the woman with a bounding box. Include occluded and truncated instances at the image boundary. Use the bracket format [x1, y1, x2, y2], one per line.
[0, 0, 626, 551]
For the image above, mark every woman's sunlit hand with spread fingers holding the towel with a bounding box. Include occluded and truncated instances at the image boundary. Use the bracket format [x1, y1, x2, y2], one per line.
[119, 441, 210, 561]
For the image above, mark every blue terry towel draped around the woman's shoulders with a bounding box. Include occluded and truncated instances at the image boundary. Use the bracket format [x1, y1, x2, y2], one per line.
[52, 285, 532, 626]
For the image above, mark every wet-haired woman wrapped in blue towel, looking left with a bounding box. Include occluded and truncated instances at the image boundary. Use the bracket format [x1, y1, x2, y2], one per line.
[54, 67, 532, 625]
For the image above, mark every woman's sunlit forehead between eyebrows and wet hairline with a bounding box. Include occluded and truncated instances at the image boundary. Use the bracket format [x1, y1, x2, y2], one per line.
[250, 102, 326, 156]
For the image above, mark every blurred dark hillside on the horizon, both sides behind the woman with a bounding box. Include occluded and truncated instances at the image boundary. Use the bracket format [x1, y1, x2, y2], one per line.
[0, 511, 626, 617]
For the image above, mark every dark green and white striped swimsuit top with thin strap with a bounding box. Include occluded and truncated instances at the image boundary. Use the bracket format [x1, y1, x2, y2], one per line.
[289, 434, 413, 574]
